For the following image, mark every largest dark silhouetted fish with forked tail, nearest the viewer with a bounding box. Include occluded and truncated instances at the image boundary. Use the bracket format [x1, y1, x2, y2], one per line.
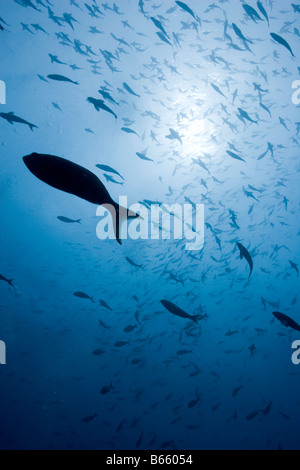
[23, 153, 139, 245]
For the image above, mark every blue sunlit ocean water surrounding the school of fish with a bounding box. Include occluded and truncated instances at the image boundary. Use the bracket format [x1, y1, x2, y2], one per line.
[0, 0, 300, 450]
